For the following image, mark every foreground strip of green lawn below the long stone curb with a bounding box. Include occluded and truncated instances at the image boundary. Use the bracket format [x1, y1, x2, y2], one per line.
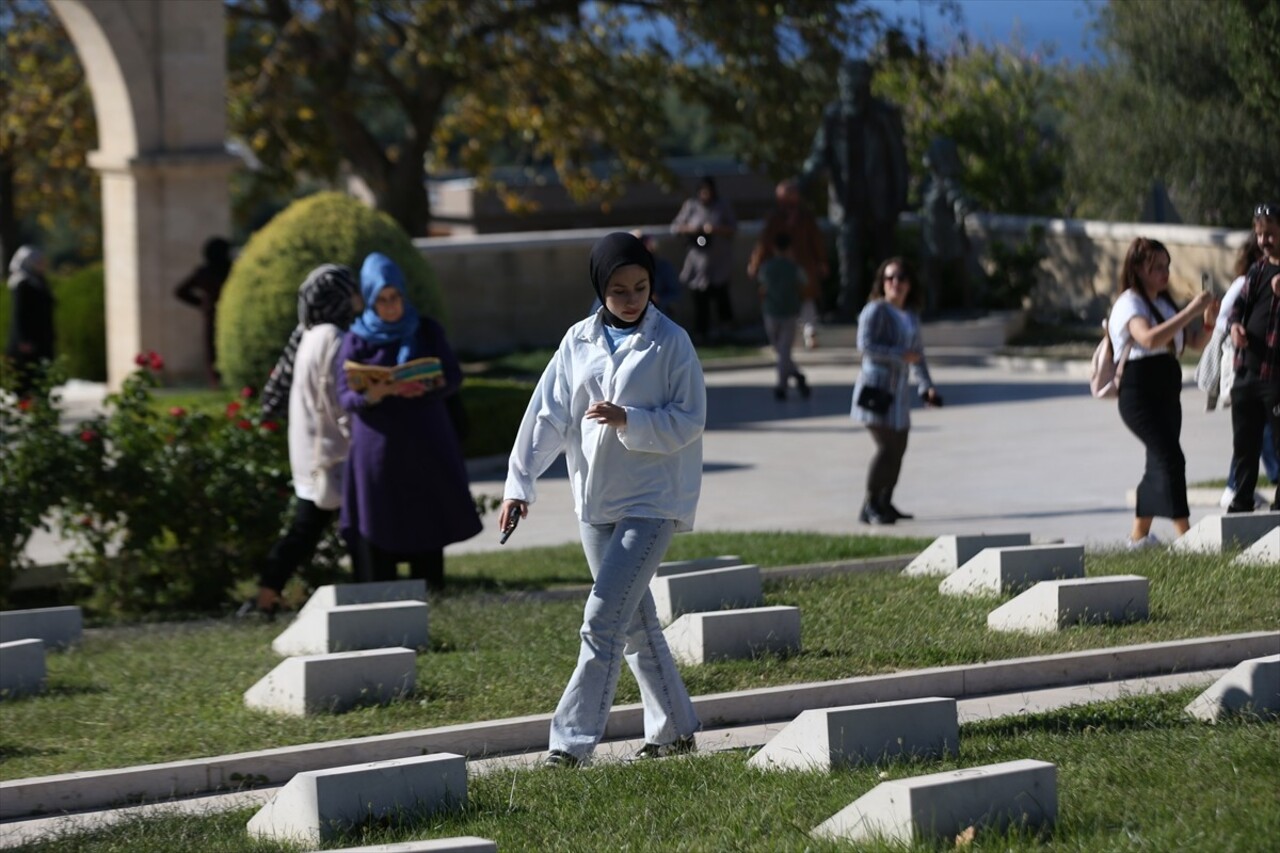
[15, 690, 1280, 853]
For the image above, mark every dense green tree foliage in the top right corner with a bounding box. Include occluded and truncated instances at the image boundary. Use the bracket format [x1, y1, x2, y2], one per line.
[1066, 0, 1280, 227]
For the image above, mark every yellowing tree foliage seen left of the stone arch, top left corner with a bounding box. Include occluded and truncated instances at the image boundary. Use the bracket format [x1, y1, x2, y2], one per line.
[0, 0, 100, 266]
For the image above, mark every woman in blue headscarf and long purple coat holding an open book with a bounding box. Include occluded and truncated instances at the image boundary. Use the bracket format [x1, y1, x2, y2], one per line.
[338, 252, 481, 590]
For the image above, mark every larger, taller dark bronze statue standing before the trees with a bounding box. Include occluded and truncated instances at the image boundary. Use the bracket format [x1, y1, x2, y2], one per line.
[799, 59, 908, 320]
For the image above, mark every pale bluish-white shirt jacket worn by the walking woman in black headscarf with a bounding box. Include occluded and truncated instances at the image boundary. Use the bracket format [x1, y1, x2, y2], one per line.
[503, 306, 707, 530]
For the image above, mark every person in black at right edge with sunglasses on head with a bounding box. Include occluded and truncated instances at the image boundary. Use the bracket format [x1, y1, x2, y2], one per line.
[1226, 202, 1280, 512]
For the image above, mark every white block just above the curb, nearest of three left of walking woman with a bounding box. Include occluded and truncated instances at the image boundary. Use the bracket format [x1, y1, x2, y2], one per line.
[244, 648, 417, 716]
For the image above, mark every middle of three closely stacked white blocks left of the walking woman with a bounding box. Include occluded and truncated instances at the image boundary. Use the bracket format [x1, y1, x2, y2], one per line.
[271, 601, 426, 657]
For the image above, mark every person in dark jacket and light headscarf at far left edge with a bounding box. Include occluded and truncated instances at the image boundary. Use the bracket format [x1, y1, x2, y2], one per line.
[4, 246, 54, 397]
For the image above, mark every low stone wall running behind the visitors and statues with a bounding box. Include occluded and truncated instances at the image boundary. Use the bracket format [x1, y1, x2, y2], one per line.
[415, 214, 1248, 353]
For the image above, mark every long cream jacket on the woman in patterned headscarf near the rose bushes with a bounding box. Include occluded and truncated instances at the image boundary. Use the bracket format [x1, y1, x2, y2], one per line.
[289, 323, 351, 510]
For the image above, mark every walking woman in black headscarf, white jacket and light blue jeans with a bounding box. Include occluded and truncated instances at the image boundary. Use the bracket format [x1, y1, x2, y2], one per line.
[499, 232, 707, 767]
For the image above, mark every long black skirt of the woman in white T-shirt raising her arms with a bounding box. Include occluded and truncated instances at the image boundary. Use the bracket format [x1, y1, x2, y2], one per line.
[1120, 355, 1187, 519]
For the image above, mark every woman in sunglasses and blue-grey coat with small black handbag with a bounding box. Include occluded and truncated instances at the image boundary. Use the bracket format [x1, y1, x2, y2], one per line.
[851, 257, 942, 524]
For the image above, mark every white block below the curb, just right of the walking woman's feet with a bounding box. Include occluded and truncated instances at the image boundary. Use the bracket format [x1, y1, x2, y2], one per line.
[748, 697, 960, 771]
